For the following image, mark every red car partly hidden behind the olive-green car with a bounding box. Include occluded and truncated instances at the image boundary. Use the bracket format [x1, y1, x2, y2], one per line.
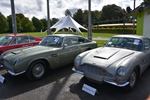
[0, 34, 42, 55]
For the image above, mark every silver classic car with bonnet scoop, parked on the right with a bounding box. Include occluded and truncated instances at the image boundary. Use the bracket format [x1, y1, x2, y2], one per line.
[72, 35, 150, 91]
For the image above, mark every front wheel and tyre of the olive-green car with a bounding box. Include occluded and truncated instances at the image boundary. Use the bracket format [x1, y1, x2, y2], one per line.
[27, 60, 46, 80]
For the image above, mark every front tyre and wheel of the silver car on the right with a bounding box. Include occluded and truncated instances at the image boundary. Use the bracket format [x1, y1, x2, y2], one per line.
[125, 69, 138, 91]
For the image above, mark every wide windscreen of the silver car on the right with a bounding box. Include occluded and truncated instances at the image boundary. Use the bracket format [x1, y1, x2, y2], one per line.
[105, 37, 143, 51]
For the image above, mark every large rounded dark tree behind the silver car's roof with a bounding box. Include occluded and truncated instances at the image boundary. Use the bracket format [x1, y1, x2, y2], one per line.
[101, 4, 127, 23]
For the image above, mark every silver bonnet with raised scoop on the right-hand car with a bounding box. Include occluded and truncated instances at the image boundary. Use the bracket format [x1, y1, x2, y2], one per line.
[82, 47, 134, 68]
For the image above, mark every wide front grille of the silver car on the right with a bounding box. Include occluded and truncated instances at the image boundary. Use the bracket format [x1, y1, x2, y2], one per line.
[80, 64, 112, 77]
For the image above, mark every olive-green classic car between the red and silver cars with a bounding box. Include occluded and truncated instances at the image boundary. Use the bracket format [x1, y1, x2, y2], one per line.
[0, 34, 97, 80]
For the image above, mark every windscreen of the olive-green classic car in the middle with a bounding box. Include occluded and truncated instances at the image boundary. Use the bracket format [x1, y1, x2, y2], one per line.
[39, 36, 63, 47]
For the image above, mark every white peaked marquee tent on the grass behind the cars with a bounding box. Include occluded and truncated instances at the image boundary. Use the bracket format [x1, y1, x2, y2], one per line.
[51, 16, 87, 33]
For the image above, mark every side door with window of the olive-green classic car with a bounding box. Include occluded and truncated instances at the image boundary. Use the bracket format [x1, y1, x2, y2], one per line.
[60, 37, 80, 65]
